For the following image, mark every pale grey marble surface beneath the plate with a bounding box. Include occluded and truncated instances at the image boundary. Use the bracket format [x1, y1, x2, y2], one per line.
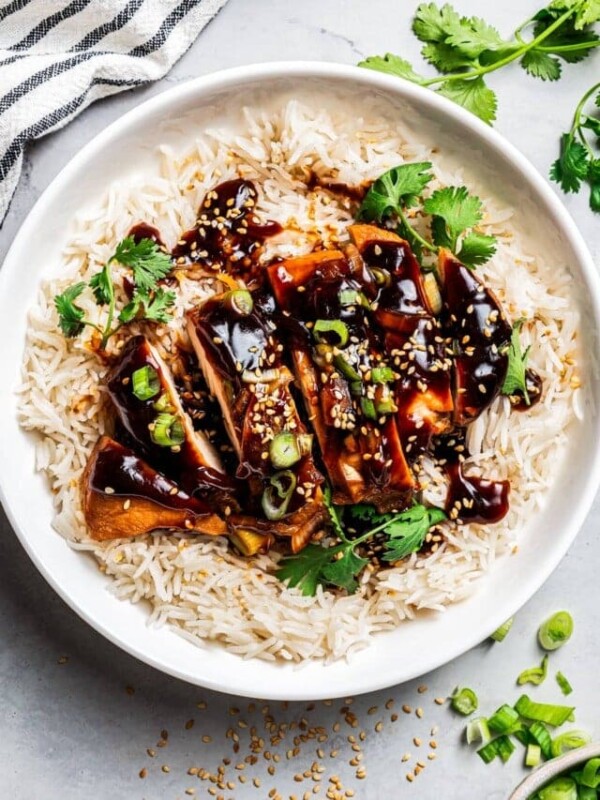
[0, 0, 600, 800]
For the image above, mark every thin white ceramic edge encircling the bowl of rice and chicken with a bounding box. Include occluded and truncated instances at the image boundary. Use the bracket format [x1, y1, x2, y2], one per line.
[0, 62, 600, 700]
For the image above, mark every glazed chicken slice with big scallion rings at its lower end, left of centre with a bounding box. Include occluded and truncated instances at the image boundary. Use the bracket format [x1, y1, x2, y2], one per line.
[188, 290, 326, 549]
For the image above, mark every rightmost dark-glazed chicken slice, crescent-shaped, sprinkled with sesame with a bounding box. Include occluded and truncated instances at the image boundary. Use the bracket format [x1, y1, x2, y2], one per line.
[439, 250, 511, 425]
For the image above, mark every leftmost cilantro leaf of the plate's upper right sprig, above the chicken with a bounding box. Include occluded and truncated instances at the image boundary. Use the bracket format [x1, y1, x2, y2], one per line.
[358, 161, 433, 222]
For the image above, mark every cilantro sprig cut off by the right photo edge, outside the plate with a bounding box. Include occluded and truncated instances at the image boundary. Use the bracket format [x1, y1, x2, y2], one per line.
[550, 83, 600, 212]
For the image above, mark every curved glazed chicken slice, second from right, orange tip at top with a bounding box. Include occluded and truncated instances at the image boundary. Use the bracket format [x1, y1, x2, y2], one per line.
[350, 225, 453, 460]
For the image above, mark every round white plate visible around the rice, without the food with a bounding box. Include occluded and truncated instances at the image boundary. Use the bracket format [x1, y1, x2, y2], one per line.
[0, 62, 600, 700]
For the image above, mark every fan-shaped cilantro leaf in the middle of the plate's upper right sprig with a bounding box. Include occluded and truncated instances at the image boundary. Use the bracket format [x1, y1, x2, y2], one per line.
[423, 186, 483, 252]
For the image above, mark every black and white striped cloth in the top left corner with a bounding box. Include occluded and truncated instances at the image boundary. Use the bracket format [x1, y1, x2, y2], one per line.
[0, 0, 226, 224]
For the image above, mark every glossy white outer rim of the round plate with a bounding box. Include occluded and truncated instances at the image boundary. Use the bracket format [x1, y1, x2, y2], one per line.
[0, 61, 600, 700]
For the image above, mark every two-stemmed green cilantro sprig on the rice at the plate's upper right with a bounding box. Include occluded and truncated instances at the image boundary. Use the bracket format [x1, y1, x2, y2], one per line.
[358, 161, 496, 267]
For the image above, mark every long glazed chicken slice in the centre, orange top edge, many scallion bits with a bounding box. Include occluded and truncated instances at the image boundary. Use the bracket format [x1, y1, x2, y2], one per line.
[268, 251, 414, 511]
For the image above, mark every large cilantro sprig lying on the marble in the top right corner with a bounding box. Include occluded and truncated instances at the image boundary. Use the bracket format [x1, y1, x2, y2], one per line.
[359, 0, 600, 124]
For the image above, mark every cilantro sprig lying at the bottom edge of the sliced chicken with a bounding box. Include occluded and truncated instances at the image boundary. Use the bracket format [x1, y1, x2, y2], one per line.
[277, 490, 446, 595]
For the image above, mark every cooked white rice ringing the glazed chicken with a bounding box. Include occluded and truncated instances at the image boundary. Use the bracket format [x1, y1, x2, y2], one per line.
[20, 100, 579, 661]
